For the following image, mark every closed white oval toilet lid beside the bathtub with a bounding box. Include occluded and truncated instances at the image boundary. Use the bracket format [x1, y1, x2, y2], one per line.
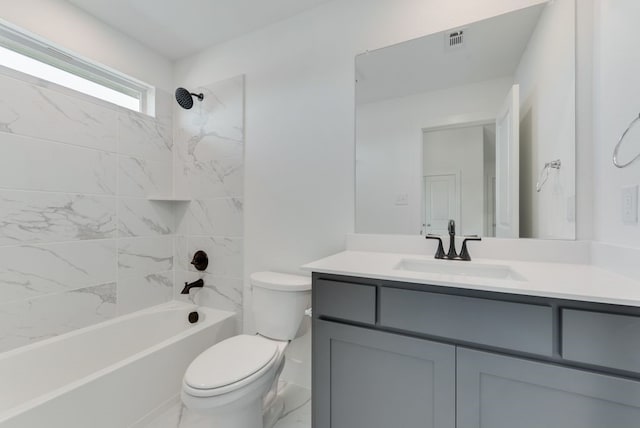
[184, 334, 278, 389]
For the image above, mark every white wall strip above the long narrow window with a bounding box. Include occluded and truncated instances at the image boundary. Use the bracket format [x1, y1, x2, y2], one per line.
[0, 0, 173, 92]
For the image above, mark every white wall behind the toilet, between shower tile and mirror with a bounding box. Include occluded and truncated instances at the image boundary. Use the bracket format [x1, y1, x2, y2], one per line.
[175, 0, 540, 390]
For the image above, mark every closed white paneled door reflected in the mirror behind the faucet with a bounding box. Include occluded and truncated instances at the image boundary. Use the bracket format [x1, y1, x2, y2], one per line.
[424, 173, 460, 235]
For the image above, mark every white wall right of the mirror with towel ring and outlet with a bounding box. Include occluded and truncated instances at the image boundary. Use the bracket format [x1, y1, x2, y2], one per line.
[593, 0, 640, 248]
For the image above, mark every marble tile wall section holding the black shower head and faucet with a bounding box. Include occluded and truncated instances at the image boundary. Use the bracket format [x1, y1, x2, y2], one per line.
[174, 76, 244, 321]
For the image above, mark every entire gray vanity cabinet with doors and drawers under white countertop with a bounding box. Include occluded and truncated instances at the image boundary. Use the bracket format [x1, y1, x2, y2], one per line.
[312, 274, 640, 428]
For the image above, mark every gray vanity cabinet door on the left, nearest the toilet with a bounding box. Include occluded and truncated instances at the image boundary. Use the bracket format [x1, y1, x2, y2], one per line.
[313, 319, 455, 428]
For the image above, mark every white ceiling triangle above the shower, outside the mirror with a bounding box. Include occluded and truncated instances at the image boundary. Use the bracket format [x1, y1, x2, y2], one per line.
[67, 0, 331, 60]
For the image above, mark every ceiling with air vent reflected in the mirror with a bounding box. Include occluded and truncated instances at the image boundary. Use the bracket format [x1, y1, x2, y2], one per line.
[356, 4, 545, 104]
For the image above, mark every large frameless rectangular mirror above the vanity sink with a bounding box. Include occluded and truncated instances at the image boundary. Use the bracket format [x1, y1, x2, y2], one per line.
[356, 0, 575, 239]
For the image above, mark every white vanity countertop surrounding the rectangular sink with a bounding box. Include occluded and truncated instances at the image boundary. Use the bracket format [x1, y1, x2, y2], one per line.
[302, 251, 640, 307]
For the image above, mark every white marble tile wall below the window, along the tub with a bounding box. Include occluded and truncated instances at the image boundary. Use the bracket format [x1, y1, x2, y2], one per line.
[0, 75, 175, 352]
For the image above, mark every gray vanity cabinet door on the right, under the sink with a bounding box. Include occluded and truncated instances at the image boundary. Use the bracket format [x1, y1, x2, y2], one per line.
[457, 348, 640, 428]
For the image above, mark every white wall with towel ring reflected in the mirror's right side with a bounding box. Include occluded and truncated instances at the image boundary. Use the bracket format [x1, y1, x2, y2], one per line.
[515, 0, 576, 239]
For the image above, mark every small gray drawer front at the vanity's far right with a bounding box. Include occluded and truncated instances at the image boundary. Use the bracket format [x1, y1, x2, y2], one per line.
[562, 309, 640, 372]
